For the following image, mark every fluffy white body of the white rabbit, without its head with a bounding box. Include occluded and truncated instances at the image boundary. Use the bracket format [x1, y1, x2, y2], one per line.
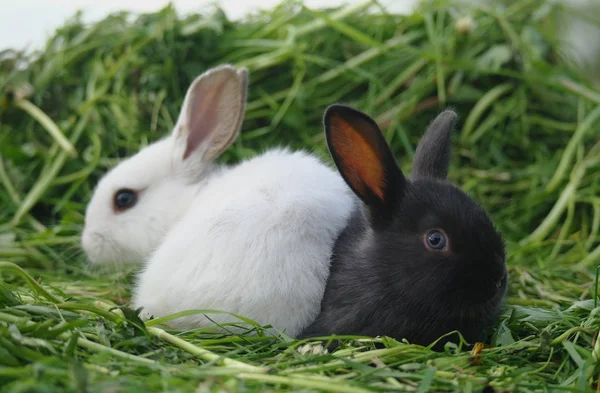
[133, 150, 352, 336]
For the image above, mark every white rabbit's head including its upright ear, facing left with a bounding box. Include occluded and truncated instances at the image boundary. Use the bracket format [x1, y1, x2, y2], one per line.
[81, 65, 248, 264]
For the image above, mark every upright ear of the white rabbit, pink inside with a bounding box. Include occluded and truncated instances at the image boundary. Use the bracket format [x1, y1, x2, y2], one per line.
[173, 65, 248, 162]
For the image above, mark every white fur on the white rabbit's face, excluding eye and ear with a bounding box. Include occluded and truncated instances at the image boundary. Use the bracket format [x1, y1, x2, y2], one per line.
[81, 138, 199, 264]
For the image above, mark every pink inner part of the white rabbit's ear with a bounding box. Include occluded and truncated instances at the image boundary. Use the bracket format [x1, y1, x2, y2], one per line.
[183, 79, 227, 160]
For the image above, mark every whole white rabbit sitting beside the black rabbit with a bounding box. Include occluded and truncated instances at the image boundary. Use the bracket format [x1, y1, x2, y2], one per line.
[82, 65, 355, 336]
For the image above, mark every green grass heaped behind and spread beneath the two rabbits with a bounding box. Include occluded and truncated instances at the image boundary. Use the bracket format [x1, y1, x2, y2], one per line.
[0, 0, 600, 393]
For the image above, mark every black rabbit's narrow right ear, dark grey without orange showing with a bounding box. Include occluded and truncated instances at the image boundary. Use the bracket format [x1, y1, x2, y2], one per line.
[411, 110, 457, 179]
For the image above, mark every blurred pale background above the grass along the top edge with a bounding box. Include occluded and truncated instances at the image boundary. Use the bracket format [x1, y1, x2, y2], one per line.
[0, 0, 600, 83]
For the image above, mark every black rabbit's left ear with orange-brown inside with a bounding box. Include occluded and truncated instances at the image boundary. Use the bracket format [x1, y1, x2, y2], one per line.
[323, 104, 406, 219]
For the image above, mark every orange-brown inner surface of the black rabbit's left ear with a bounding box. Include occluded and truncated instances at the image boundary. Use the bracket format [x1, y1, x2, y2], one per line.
[328, 112, 386, 201]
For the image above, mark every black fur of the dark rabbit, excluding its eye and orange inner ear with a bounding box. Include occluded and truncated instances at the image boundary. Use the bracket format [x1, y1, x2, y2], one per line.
[300, 105, 507, 349]
